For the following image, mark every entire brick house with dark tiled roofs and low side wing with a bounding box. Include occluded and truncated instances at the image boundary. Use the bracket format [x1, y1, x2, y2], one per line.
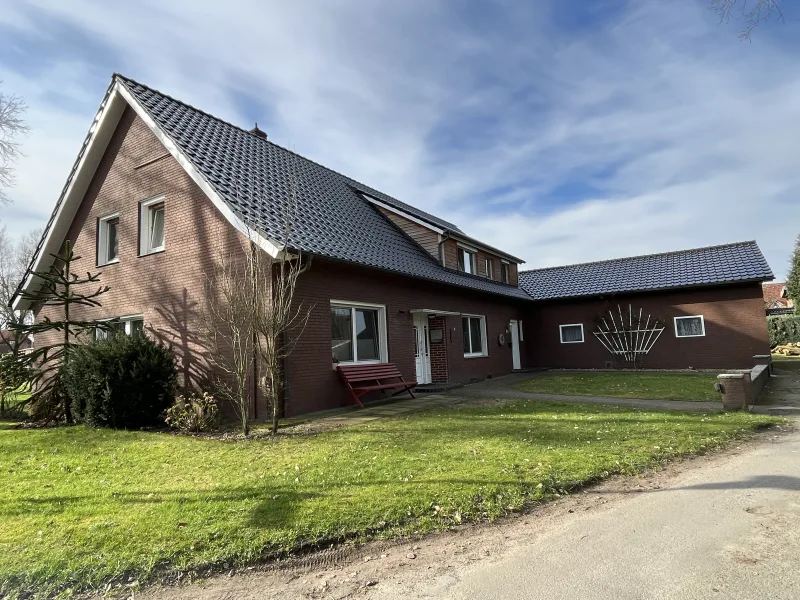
[14, 75, 772, 416]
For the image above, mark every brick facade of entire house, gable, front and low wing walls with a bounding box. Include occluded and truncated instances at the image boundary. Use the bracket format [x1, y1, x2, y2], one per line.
[29, 103, 769, 416]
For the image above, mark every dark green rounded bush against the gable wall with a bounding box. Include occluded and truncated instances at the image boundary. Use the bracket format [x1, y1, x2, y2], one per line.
[62, 335, 177, 429]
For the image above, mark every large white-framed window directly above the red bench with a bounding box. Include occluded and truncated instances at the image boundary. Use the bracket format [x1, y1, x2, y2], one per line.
[331, 300, 389, 364]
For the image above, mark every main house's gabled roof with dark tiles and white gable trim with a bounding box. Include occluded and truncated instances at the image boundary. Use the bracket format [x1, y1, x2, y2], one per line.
[10, 75, 530, 306]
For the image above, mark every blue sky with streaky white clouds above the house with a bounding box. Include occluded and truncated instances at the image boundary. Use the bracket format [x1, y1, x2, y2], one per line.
[0, 0, 800, 277]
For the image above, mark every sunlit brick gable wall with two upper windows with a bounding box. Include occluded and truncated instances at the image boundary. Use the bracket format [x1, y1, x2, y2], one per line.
[32, 109, 263, 408]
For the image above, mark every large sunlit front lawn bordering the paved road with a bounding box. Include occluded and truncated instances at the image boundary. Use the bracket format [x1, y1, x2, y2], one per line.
[0, 401, 778, 597]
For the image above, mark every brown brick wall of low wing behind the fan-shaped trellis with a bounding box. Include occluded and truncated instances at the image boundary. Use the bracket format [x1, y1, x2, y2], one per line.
[525, 284, 769, 369]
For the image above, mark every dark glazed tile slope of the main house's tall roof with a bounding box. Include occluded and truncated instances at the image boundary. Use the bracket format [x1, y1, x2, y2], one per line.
[116, 75, 530, 300]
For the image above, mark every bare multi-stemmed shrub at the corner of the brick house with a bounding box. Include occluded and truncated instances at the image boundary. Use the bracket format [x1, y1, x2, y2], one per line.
[204, 158, 311, 435]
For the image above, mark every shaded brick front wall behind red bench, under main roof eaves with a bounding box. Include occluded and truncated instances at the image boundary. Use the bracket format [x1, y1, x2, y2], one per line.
[286, 258, 526, 415]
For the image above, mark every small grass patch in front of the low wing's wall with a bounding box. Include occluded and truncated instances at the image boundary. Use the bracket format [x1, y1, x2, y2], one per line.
[515, 372, 722, 402]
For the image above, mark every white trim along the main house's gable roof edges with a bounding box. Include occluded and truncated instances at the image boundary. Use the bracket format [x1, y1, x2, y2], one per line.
[12, 80, 284, 310]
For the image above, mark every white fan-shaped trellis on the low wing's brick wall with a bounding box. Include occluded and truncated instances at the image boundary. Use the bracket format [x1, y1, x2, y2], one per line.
[593, 304, 664, 364]
